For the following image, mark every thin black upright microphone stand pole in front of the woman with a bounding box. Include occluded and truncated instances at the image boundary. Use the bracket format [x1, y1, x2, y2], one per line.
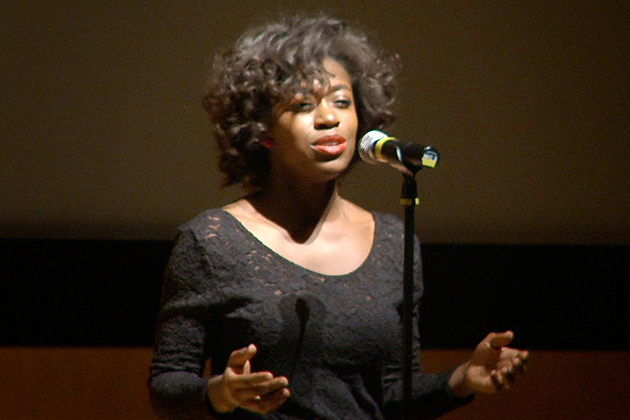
[400, 165, 422, 420]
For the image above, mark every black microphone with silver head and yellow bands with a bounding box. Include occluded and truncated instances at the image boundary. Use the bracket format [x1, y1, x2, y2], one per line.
[359, 130, 440, 173]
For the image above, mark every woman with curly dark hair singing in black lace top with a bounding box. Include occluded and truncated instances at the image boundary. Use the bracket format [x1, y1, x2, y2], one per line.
[149, 16, 528, 420]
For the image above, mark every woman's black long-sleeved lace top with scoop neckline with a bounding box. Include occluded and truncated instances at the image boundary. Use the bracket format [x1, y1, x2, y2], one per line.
[149, 209, 467, 420]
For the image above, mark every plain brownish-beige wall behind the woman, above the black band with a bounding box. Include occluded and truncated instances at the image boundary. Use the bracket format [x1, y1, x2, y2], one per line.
[0, 0, 630, 244]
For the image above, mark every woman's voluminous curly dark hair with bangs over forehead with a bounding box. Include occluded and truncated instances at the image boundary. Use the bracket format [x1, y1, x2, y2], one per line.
[203, 16, 395, 189]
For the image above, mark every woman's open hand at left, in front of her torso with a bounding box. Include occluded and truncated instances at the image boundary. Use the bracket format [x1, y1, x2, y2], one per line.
[208, 344, 290, 413]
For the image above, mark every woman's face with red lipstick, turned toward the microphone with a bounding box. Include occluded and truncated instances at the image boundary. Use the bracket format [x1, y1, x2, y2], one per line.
[270, 58, 358, 182]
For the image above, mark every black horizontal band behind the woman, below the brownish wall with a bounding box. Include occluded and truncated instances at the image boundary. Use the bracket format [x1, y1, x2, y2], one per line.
[0, 240, 630, 350]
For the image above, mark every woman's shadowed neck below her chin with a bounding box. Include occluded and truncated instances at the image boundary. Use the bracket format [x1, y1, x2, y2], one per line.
[248, 180, 342, 243]
